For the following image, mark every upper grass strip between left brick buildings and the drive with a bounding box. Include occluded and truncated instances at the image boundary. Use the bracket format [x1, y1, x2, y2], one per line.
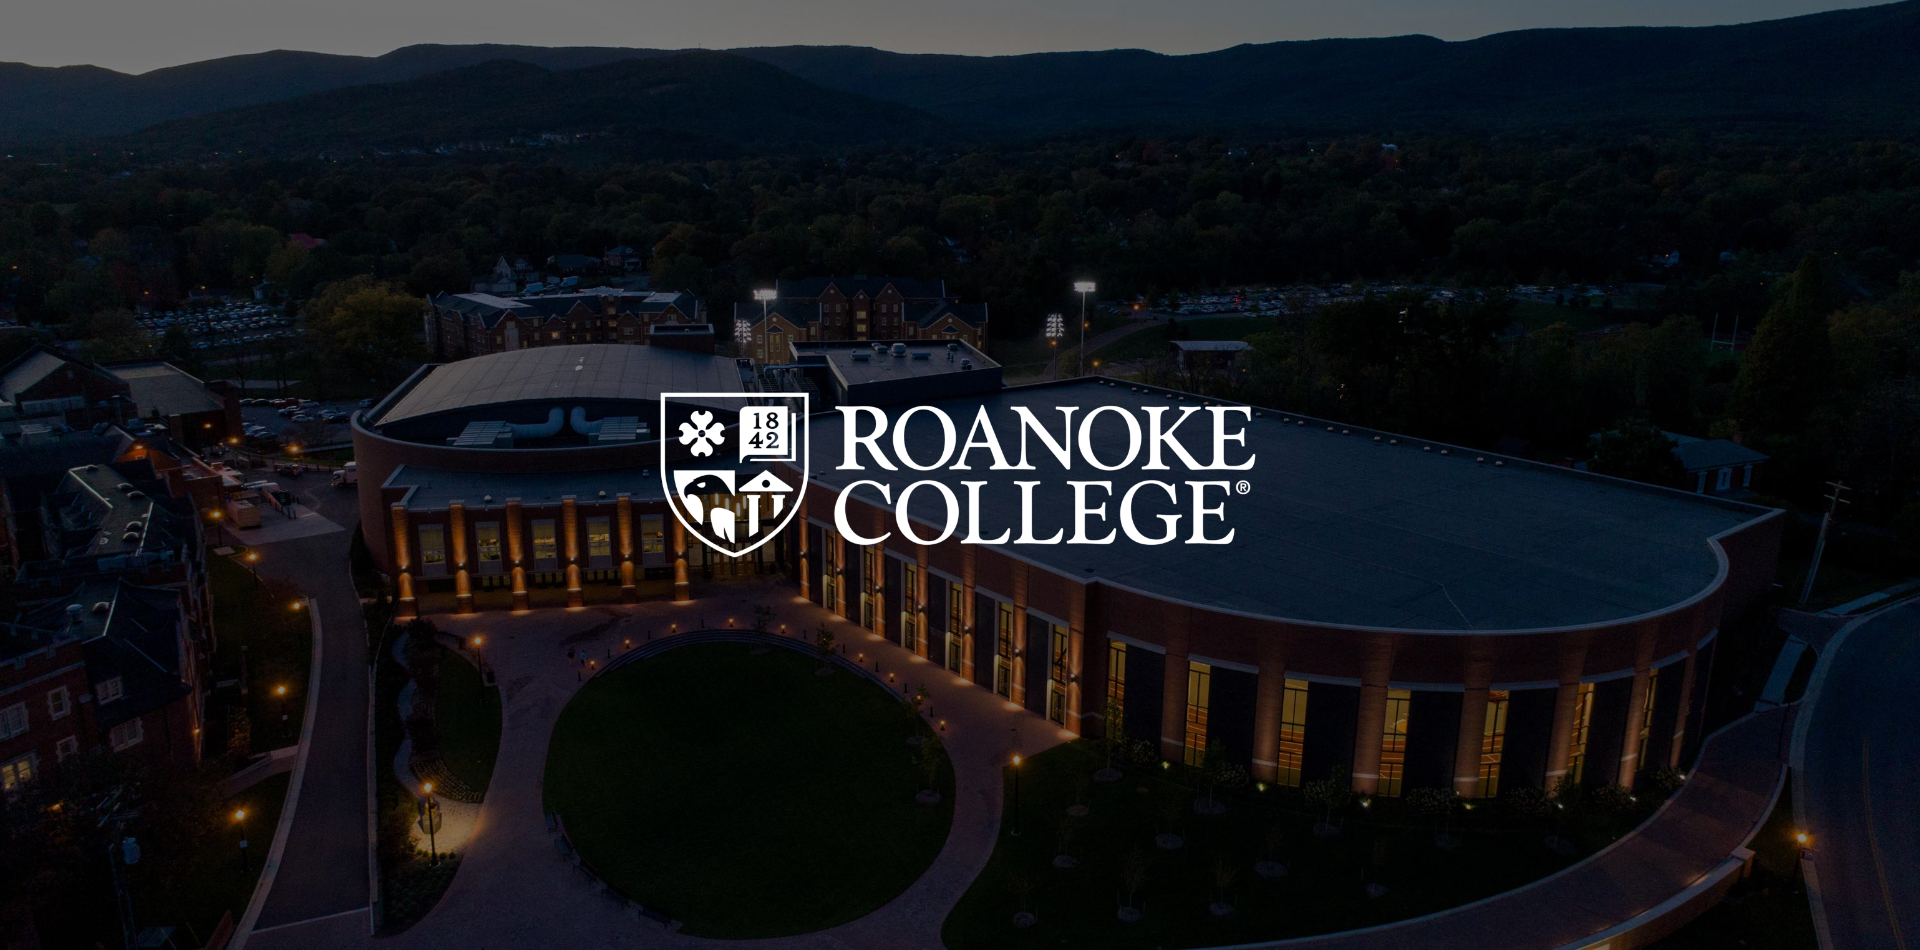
[207, 551, 313, 754]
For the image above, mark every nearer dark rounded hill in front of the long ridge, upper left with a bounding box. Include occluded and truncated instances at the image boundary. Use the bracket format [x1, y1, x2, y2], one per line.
[123, 52, 947, 157]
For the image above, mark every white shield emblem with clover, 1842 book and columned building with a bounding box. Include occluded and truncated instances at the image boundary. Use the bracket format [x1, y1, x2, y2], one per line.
[660, 393, 810, 557]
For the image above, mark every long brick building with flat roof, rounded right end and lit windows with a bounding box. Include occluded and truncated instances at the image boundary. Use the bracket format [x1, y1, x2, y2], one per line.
[789, 378, 1782, 796]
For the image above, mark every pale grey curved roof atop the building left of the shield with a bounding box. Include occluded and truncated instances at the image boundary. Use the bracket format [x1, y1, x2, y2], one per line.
[374, 344, 745, 426]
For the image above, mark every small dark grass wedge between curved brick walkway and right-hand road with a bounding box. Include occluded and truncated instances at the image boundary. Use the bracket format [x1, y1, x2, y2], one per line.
[1661, 783, 1818, 950]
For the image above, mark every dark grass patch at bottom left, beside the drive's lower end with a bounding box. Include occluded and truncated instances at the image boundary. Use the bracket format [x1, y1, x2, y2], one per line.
[131, 773, 292, 946]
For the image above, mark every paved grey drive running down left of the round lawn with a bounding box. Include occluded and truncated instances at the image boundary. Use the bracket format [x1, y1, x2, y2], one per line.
[248, 476, 369, 946]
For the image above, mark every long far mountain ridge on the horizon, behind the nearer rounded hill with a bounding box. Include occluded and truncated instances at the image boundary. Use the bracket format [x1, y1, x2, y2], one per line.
[0, 0, 1920, 144]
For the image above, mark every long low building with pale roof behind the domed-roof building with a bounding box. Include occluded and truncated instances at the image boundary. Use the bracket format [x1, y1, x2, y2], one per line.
[426, 288, 712, 359]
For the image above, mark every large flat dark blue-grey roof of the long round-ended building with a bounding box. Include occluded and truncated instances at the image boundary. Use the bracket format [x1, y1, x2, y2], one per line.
[810, 382, 1764, 631]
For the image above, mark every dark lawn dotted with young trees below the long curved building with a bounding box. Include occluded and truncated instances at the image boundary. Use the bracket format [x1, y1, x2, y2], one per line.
[943, 741, 1653, 950]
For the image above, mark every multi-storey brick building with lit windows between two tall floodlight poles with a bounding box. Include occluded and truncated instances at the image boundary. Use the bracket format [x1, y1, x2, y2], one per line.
[733, 276, 987, 363]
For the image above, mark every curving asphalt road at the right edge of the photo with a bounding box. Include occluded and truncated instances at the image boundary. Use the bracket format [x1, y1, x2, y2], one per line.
[1793, 601, 1920, 950]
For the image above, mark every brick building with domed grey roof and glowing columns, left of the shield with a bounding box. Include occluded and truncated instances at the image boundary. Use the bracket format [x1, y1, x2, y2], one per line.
[353, 344, 780, 616]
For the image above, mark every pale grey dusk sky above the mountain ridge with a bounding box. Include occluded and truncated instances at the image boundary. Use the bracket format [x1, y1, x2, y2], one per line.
[0, 0, 1870, 73]
